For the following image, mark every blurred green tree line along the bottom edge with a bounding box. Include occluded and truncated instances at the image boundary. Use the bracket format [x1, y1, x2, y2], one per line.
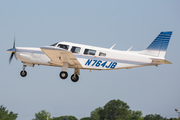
[0, 99, 180, 120]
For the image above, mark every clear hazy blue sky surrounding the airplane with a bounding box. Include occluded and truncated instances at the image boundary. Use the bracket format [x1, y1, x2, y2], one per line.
[0, 0, 180, 120]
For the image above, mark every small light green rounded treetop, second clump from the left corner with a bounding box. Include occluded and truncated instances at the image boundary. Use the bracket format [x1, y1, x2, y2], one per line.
[33, 110, 51, 120]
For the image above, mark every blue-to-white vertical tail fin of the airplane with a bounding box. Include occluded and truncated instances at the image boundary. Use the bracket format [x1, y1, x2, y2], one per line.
[141, 31, 172, 58]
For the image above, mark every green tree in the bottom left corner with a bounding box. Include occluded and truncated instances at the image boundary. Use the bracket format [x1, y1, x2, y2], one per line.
[0, 105, 18, 120]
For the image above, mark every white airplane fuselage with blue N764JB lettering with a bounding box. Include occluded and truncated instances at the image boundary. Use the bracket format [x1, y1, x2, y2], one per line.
[15, 42, 161, 70]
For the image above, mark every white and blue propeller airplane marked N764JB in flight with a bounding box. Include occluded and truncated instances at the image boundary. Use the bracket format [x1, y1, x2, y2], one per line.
[7, 31, 172, 82]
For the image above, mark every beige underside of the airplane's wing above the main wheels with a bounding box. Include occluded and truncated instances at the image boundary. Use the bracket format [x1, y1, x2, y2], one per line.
[41, 46, 82, 68]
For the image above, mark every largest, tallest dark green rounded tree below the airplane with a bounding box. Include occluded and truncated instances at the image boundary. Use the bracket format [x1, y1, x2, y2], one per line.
[89, 99, 143, 120]
